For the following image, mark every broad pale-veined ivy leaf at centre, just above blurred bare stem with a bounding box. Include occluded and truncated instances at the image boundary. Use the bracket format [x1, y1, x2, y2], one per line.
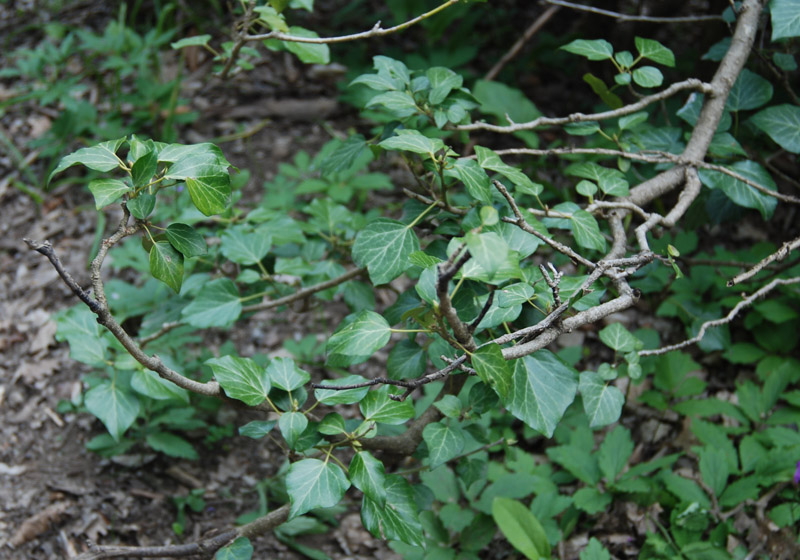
[353, 218, 419, 285]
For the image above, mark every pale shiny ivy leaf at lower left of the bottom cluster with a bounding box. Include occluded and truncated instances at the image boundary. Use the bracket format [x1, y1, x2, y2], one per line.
[286, 459, 350, 519]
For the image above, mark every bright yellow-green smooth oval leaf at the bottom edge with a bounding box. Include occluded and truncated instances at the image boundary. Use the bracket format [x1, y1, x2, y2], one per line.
[492, 497, 550, 560]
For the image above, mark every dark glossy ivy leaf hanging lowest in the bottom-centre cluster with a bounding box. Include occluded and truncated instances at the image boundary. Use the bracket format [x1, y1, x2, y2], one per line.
[361, 475, 425, 546]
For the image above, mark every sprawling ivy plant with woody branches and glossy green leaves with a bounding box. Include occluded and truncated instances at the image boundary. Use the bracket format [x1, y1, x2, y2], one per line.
[23, 0, 800, 556]
